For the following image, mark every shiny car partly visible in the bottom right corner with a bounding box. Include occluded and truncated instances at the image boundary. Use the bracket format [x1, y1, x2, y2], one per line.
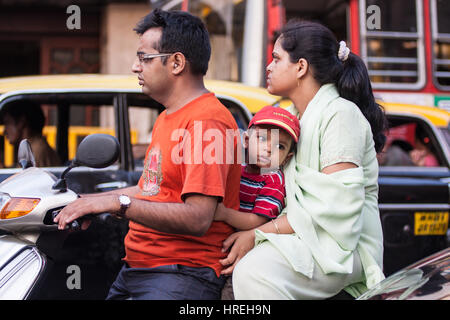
[357, 248, 450, 300]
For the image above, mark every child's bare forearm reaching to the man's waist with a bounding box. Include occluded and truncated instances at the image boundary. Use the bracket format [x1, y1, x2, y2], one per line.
[214, 203, 269, 230]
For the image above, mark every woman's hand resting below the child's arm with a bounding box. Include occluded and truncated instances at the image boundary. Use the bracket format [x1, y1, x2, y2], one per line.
[219, 229, 255, 275]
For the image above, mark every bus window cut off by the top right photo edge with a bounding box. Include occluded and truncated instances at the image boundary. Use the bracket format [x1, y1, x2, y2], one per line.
[430, 0, 450, 90]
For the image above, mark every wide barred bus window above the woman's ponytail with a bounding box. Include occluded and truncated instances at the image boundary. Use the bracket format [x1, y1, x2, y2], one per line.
[360, 0, 425, 90]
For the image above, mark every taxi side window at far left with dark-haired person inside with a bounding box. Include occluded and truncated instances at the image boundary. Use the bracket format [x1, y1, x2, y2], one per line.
[0, 99, 116, 168]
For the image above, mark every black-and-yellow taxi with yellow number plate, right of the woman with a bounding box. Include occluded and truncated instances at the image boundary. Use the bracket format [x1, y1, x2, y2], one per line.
[378, 103, 450, 275]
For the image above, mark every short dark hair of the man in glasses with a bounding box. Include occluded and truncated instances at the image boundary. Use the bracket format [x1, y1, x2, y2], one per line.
[133, 9, 211, 75]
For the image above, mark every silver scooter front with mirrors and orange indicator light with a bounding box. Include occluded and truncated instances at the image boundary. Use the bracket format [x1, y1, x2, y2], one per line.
[0, 134, 119, 300]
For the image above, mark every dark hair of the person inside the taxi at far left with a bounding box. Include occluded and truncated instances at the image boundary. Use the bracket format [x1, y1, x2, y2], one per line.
[0, 100, 45, 135]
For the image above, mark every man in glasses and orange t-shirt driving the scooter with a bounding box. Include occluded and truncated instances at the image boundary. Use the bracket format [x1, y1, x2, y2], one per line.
[55, 9, 240, 299]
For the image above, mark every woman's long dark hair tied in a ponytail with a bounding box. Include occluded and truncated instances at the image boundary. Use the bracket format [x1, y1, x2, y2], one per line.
[280, 19, 387, 153]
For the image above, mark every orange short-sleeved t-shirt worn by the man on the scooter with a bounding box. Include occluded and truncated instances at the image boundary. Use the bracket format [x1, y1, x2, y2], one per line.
[124, 93, 241, 276]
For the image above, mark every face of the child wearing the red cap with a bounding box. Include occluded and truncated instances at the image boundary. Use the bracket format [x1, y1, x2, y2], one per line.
[245, 125, 294, 169]
